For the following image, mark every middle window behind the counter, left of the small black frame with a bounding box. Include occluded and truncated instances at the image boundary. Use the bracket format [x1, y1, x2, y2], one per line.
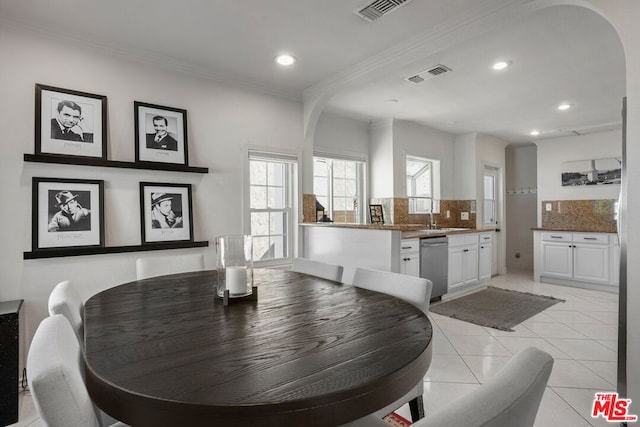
[313, 157, 364, 223]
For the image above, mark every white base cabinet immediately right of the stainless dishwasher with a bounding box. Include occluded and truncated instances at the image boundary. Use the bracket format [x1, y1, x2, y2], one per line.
[448, 233, 478, 292]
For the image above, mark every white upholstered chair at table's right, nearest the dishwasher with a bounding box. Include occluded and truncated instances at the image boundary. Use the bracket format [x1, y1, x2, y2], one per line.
[352, 268, 433, 421]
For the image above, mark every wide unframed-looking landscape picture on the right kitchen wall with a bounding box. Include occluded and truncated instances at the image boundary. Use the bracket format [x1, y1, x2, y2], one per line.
[561, 157, 622, 187]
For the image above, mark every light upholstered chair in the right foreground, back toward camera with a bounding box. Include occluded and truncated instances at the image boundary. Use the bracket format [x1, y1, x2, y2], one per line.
[350, 347, 553, 427]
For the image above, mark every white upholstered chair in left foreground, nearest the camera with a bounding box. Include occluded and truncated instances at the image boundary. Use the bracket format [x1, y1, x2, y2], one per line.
[27, 314, 131, 427]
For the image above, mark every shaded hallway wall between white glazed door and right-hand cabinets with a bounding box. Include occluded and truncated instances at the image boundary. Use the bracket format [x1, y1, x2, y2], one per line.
[505, 144, 538, 270]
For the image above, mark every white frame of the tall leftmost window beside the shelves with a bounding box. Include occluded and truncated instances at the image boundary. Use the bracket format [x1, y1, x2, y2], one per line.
[243, 148, 300, 267]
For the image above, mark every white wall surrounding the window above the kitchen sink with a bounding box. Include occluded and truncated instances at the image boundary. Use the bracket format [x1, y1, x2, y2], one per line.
[393, 120, 455, 199]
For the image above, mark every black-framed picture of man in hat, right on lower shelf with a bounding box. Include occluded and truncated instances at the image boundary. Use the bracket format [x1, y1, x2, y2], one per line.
[140, 182, 193, 245]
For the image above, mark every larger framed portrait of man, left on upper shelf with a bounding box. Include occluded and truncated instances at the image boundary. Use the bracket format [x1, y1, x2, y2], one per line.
[35, 84, 107, 160]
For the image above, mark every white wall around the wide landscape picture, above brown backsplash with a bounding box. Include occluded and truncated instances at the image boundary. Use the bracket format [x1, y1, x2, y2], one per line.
[536, 130, 622, 225]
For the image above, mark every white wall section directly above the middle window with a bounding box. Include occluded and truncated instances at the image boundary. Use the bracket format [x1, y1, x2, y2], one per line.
[313, 111, 370, 159]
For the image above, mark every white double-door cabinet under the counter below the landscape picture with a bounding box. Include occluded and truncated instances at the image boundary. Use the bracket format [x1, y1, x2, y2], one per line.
[540, 232, 611, 284]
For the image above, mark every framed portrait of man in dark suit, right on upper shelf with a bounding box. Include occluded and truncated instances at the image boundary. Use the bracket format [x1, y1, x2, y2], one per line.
[133, 101, 189, 166]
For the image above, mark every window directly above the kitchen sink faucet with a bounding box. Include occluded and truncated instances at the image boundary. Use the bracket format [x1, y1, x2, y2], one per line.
[405, 156, 440, 213]
